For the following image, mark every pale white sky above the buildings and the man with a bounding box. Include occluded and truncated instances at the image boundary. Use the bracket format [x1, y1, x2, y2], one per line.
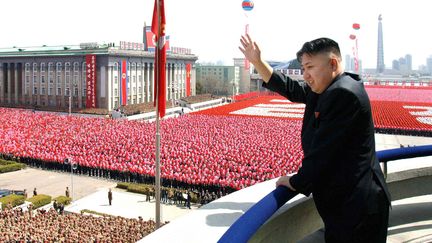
[0, 0, 432, 69]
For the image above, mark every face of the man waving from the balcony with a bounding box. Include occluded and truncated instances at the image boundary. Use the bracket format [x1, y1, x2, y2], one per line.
[301, 53, 335, 94]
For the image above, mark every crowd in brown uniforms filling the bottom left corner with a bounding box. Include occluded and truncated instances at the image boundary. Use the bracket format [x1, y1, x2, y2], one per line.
[0, 204, 156, 242]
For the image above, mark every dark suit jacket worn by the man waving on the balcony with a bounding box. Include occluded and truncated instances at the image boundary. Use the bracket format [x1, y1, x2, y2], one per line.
[263, 71, 390, 237]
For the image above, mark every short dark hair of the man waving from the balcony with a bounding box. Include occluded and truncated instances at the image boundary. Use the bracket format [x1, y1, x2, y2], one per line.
[297, 37, 342, 63]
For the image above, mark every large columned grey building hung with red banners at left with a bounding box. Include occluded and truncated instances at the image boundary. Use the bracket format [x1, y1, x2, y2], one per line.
[0, 43, 197, 110]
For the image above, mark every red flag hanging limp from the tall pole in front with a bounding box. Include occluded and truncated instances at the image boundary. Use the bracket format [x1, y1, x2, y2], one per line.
[152, 0, 166, 118]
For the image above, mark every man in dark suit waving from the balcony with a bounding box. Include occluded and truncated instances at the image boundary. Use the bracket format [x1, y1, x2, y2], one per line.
[240, 35, 390, 242]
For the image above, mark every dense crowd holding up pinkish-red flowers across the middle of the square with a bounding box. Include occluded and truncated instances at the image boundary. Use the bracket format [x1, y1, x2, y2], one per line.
[0, 108, 303, 189]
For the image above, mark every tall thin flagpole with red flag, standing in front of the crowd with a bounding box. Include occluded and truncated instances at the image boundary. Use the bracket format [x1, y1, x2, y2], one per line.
[155, 0, 161, 229]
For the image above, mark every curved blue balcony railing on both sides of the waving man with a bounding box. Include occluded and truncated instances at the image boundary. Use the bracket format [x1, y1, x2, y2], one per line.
[218, 145, 432, 243]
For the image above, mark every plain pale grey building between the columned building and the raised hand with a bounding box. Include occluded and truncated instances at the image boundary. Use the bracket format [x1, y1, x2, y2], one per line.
[196, 64, 240, 95]
